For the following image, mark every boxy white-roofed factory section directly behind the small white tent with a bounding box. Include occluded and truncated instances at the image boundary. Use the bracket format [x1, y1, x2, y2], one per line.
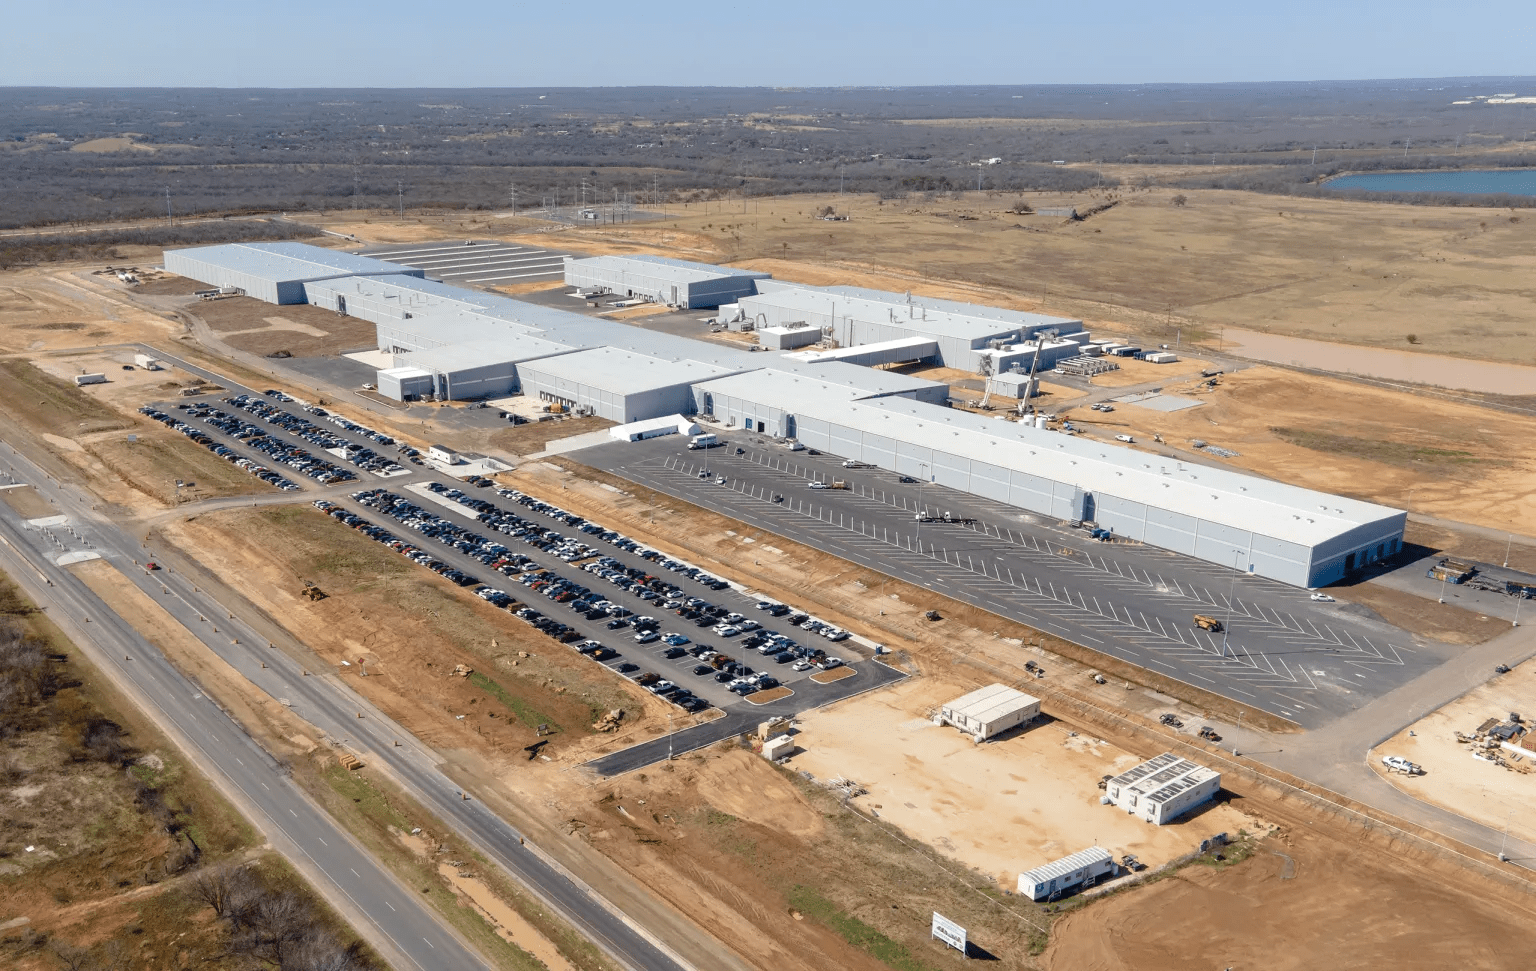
[518, 347, 730, 424]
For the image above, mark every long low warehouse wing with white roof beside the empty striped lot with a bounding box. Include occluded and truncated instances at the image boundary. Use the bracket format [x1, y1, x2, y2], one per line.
[796, 396, 1407, 587]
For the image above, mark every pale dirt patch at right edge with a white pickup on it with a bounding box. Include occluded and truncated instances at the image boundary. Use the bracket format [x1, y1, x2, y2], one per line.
[1370, 651, 1536, 842]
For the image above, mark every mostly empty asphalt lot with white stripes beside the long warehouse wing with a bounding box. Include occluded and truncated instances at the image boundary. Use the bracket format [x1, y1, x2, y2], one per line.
[576, 430, 1453, 728]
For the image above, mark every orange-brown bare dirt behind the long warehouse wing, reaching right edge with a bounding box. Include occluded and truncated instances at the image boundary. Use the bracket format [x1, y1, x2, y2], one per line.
[1071, 367, 1536, 537]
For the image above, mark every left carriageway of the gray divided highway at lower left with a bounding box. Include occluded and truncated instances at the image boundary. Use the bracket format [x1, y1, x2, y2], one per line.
[0, 456, 487, 971]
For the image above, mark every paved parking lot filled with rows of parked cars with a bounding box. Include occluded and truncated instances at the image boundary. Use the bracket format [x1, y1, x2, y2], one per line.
[154, 372, 905, 773]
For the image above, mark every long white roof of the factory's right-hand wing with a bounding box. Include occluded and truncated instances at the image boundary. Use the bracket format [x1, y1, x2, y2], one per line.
[854, 396, 1402, 545]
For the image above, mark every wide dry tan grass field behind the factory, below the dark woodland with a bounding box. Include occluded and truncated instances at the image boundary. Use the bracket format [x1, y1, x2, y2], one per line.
[516, 187, 1536, 364]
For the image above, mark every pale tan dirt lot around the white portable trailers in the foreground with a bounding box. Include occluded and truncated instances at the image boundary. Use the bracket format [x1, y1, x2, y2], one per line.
[790, 674, 1264, 890]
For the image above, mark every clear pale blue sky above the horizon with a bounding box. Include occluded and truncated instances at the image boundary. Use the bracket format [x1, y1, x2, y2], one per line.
[12, 0, 1536, 88]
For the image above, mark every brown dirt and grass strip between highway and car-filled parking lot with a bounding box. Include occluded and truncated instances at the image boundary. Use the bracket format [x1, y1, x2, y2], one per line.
[158, 507, 687, 771]
